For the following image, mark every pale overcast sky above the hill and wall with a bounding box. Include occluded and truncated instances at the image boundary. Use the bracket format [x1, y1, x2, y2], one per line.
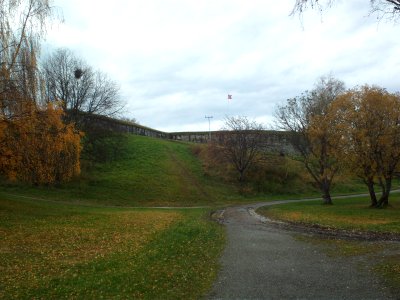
[45, 0, 400, 131]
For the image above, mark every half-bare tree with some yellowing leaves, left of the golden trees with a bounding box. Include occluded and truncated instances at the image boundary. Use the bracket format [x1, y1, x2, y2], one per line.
[276, 76, 345, 204]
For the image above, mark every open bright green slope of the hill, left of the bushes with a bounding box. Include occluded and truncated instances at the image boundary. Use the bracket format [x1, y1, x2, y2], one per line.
[0, 135, 235, 206]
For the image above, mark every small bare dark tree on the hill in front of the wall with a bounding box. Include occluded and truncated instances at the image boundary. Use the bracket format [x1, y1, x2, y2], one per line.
[216, 116, 263, 182]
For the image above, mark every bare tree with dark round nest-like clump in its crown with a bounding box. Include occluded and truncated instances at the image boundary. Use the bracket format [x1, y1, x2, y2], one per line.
[42, 49, 123, 128]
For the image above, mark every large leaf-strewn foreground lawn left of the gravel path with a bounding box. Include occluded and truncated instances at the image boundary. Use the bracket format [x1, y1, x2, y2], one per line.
[0, 194, 224, 299]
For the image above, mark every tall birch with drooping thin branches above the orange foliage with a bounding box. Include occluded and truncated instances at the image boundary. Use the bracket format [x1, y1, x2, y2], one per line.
[0, 0, 53, 122]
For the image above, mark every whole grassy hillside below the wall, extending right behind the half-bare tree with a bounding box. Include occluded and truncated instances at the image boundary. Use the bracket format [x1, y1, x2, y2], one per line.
[2, 135, 374, 207]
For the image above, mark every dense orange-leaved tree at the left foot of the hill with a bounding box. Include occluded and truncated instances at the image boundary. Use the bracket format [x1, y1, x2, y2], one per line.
[0, 102, 81, 184]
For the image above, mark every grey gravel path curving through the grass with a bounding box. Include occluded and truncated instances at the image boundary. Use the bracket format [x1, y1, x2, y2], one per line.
[207, 201, 399, 299]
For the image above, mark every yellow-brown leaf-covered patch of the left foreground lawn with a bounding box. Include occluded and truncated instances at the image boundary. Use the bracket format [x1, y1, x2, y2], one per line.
[0, 200, 181, 298]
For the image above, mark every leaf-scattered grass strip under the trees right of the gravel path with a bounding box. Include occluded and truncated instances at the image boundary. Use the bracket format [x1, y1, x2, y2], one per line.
[258, 194, 400, 234]
